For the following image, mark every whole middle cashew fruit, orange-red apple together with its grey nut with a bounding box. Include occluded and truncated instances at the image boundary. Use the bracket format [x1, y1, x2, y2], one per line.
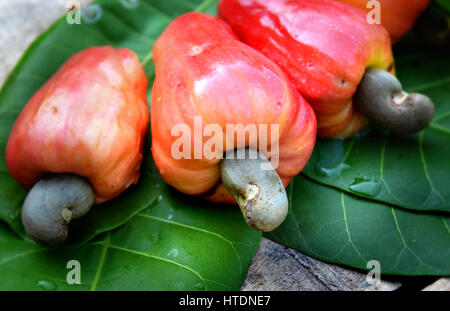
[151, 13, 316, 231]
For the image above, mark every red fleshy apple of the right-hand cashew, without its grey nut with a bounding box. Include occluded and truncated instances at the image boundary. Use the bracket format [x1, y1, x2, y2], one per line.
[218, 0, 394, 137]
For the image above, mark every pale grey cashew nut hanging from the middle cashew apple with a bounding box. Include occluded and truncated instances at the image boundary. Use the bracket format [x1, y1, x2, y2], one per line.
[220, 149, 288, 231]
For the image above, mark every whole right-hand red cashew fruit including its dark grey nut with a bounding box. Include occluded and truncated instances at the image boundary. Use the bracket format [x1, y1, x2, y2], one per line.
[218, 0, 434, 137]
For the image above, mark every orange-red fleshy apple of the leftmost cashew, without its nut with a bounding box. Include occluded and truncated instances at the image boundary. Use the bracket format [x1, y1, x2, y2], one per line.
[6, 46, 149, 203]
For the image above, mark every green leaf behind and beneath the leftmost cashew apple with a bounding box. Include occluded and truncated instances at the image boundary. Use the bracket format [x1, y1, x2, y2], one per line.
[0, 0, 216, 244]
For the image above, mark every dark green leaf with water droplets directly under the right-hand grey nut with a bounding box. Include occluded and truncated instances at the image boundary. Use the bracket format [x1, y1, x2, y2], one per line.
[304, 47, 450, 212]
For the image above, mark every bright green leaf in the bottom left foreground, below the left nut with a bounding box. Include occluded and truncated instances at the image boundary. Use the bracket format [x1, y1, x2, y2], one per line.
[0, 184, 261, 290]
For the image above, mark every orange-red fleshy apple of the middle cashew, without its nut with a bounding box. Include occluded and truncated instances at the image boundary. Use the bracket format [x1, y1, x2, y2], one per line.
[151, 13, 317, 203]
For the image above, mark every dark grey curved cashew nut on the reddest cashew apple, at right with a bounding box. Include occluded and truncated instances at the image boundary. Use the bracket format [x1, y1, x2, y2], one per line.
[354, 69, 434, 134]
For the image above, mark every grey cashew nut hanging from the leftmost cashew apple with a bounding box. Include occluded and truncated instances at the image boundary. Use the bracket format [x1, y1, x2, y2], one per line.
[22, 174, 94, 246]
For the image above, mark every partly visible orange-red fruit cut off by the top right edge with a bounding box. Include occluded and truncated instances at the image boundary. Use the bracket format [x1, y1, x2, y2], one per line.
[335, 0, 430, 44]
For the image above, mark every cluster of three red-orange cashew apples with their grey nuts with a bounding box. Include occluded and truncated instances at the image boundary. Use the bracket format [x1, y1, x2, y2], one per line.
[6, 0, 433, 245]
